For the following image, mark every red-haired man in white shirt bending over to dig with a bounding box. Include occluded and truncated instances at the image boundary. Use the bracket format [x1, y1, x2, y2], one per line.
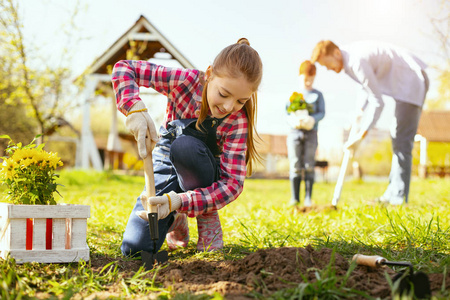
[311, 40, 429, 205]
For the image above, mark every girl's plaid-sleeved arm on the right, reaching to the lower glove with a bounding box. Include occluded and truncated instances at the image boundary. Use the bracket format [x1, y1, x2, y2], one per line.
[179, 111, 247, 217]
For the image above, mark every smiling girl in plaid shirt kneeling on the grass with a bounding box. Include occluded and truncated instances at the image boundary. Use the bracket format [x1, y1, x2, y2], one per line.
[112, 38, 262, 255]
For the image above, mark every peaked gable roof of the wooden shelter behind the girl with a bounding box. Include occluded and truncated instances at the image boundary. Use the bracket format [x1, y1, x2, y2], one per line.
[88, 16, 194, 74]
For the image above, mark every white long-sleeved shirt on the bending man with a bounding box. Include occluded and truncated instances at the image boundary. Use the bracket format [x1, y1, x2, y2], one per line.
[339, 41, 427, 130]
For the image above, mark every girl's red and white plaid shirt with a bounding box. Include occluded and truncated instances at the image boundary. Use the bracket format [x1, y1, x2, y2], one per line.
[112, 60, 248, 217]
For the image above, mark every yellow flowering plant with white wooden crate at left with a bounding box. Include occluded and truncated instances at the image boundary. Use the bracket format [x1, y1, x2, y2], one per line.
[0, 135, 90, 263]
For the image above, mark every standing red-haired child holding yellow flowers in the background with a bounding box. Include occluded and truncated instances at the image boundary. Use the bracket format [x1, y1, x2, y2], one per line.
[287, 60, 325, 206]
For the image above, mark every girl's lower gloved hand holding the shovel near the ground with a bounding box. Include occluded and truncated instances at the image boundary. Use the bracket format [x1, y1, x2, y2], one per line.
[136, 191, 181, 221]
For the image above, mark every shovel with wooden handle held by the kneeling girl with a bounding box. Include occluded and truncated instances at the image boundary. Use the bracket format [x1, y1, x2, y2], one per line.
[141, 142, 169, 270]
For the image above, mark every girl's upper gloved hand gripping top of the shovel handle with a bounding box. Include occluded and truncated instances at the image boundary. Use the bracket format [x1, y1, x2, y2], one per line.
[125, 101, 158, 159]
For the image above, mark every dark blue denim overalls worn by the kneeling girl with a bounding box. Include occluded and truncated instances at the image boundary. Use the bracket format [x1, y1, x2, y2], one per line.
[121, 118, 222, 256]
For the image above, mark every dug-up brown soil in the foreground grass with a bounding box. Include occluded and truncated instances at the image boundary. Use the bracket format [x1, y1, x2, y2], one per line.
[91, 246, 450, 299]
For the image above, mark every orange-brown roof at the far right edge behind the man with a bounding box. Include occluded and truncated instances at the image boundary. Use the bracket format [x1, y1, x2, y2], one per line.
[417, 110, 450, 143]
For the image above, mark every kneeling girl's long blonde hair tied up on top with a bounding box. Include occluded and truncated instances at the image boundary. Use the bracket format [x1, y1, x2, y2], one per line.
[196, 38, 262, 176]
